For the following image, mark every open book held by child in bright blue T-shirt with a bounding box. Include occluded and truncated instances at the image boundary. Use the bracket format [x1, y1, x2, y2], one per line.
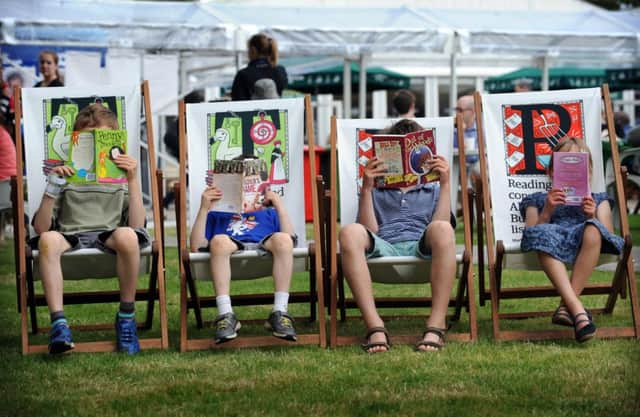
[207, 159, 269, 213]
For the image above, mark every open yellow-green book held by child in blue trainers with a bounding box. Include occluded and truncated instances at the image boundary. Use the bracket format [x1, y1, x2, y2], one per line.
[65, 129, 127, 184]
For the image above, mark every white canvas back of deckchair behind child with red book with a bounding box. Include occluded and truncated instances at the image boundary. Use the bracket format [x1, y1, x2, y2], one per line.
[337, 117, 460, 225]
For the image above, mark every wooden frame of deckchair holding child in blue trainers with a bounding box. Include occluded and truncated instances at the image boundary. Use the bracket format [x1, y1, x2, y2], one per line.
[12, 81, 169, 354]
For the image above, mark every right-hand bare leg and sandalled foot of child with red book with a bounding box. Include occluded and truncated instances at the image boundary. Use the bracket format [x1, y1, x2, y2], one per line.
[420, 221, 456, 350]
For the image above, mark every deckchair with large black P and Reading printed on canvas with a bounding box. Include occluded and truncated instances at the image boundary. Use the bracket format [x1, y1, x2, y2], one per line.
[475, 85, 640, 340]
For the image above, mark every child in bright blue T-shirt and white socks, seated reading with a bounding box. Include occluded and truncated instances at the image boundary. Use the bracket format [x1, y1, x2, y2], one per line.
[190, 155, 297, 343]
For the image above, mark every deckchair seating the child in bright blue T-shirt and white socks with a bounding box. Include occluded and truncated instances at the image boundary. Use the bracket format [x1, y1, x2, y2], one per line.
[175, 96, 326, 351]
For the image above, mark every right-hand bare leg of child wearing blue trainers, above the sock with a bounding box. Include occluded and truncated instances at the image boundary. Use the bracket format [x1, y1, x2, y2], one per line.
[105, 227, 140, 303]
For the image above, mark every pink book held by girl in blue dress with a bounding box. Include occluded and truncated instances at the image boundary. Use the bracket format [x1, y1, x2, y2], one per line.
[553, 152, 591, 206]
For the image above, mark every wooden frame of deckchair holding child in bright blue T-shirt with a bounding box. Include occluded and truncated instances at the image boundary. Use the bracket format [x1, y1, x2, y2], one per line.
[174, 95, 327, 352]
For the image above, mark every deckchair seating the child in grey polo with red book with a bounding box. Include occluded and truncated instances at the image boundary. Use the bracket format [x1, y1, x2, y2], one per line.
[327, 117, 477, 347]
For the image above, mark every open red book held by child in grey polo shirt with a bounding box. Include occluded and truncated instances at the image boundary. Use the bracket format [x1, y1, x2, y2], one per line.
[371, 129, 439, 188]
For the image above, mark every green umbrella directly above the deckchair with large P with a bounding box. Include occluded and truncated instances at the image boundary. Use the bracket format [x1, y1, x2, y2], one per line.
[484, 67, 606, 93]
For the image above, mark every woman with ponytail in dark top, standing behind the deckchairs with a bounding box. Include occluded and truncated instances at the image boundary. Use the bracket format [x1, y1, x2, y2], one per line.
[231, 33, 289, 100]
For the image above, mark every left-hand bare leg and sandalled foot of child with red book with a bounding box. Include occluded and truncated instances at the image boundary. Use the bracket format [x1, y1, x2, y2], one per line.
[340, 223, 386, 352]
